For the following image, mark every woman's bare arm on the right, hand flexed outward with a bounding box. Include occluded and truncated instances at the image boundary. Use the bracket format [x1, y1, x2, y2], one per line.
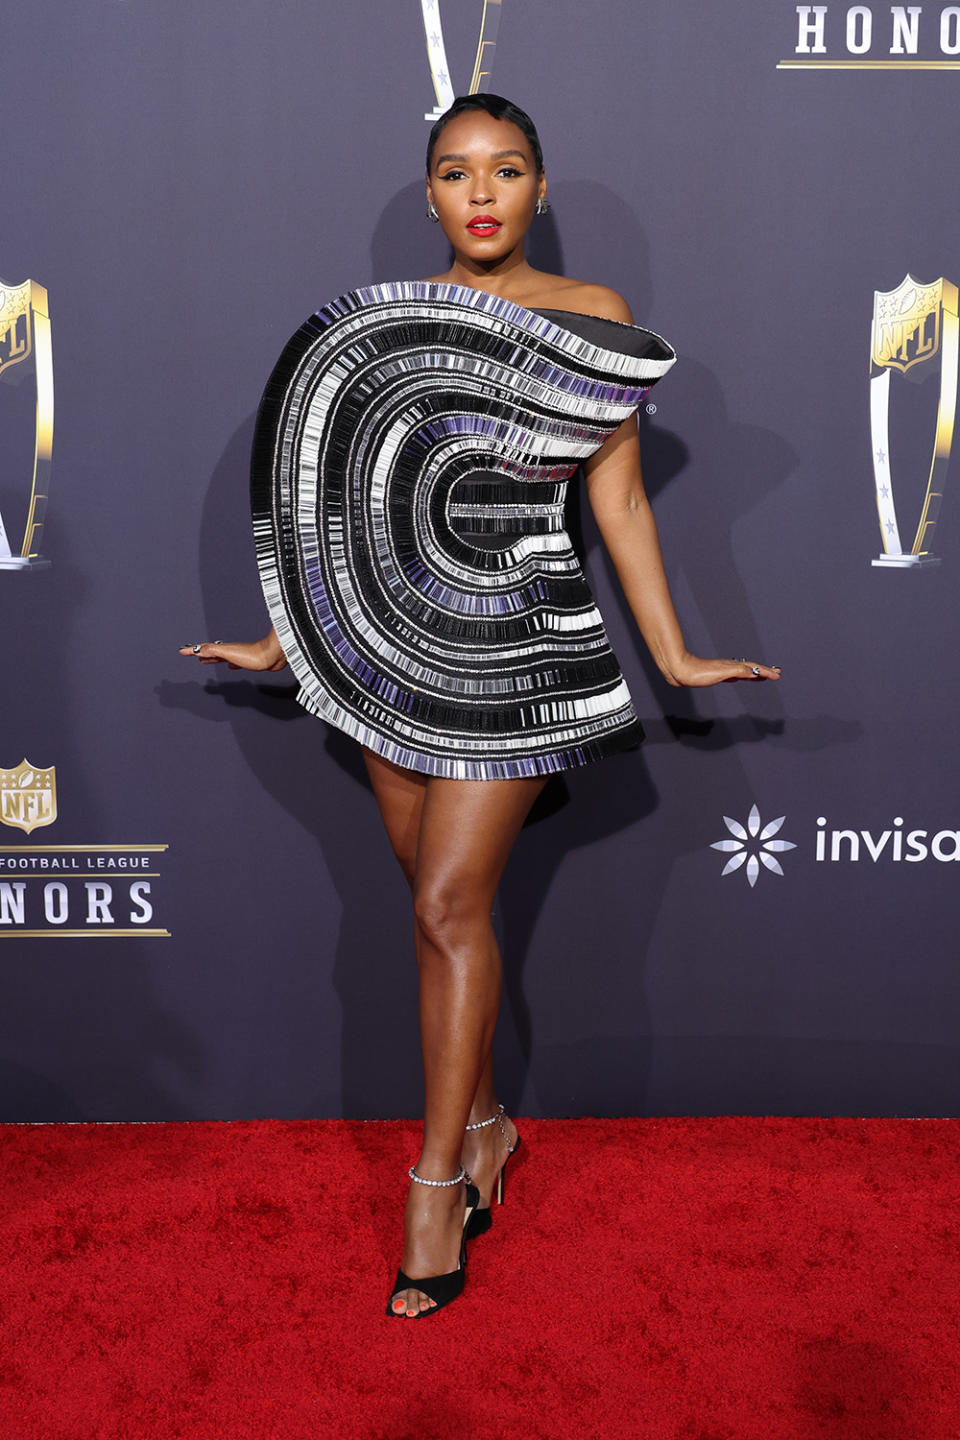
[584, 411, 780, 685]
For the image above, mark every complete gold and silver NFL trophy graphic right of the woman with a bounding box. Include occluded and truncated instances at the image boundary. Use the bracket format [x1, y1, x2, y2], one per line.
[869, 274, 960, 569]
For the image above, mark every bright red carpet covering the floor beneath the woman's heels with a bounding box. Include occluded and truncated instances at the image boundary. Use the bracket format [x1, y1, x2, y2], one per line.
[0, 1119, 960, 1440]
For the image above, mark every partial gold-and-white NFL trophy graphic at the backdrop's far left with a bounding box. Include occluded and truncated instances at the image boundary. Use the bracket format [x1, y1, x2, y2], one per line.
[0, 279, 53, 570]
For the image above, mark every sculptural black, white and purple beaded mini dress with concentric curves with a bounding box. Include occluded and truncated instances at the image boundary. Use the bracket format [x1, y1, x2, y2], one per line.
[250, 281, 675, 780]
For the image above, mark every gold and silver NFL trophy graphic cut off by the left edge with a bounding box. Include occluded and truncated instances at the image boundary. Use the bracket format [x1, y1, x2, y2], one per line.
[0, 279, 53, 570]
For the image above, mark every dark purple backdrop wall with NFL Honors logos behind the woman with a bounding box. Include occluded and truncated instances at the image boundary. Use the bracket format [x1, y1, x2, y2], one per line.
[0, 0, 960, 1120]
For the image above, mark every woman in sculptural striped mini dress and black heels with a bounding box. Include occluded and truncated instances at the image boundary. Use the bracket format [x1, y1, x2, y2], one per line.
[181, 95, 779, 1318]
